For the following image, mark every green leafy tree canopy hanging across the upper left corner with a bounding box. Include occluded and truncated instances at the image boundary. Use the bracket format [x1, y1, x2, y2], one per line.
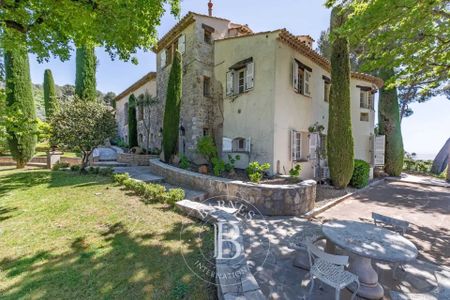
[0, 0, 180, 61]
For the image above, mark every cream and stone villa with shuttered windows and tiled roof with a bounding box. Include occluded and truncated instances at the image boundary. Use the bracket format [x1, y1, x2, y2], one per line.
[116, 12, 384, 179]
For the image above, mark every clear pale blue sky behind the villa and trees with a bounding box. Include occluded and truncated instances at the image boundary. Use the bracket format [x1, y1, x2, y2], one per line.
[31, 0, 450, 154]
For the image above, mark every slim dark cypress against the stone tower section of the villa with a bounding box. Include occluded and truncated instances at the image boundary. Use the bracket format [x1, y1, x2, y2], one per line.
[163, 51, 183, 162]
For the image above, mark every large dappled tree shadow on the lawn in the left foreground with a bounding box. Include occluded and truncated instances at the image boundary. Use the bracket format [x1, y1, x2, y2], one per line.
[0, 222, 214, 299]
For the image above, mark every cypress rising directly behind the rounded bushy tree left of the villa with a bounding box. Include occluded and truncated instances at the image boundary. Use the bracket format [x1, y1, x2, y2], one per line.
[75, 46, 97, 101]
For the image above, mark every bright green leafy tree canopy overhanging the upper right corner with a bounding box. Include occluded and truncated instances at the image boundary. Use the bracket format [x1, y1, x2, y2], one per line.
[326, 0, 450, 97]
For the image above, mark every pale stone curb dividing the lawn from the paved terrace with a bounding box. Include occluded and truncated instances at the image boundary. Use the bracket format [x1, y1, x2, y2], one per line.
[175, 199, 266, 300]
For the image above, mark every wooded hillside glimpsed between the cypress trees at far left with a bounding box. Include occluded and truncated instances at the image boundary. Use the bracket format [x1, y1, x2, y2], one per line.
[33, 84, 116, 119]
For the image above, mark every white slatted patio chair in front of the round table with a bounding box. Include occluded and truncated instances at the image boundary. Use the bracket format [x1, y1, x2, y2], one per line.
[307, 242, 359, 300]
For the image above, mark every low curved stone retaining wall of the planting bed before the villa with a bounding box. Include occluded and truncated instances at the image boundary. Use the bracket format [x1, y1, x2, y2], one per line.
[149, 159, 316, 216]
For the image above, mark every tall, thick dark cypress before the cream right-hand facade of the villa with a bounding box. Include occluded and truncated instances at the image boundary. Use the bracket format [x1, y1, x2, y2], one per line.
[327, 7, 354, 188]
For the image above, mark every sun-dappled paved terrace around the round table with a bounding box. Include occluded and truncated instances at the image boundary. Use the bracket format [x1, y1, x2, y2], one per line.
[244, 182, 450, 299]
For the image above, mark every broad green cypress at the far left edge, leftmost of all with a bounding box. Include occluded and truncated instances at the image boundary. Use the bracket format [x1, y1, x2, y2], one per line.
[4, 45, 37, 169]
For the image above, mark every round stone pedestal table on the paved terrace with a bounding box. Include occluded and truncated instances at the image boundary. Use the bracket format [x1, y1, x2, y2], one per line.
[322, 220, 418, 299]
